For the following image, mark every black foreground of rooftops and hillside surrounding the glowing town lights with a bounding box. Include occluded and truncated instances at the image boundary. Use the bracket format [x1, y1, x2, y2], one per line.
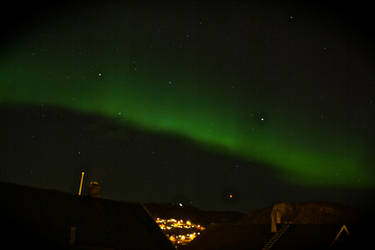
[0, 183, 374, 250]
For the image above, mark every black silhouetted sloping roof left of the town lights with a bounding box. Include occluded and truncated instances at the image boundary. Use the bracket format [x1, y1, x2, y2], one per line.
[0, 183, 174, 250]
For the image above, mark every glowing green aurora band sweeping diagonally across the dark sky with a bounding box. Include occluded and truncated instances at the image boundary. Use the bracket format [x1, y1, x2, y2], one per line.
[0, 26, 375, 188]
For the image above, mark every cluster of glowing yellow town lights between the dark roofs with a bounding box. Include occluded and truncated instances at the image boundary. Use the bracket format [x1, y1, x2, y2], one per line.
[155, 218, 206, 245]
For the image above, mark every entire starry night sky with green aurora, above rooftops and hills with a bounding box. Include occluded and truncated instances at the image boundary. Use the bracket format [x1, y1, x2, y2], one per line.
[0, 1, 375, 211]
